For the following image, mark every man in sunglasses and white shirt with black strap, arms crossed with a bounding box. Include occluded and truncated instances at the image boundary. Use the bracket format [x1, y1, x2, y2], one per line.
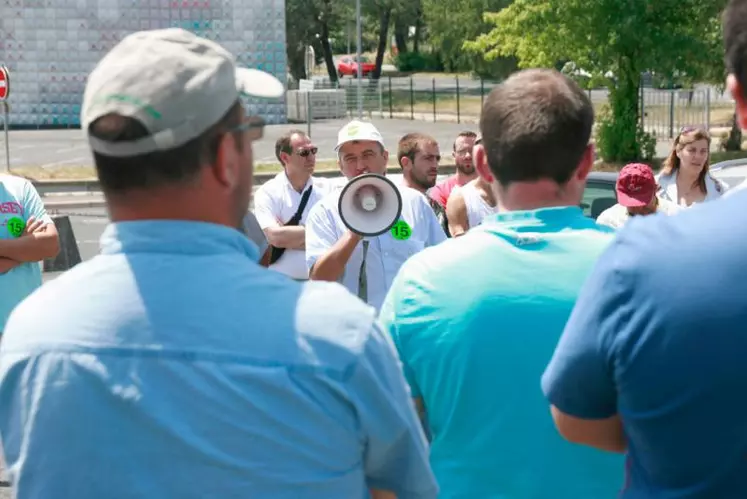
[254, 130, 328, 281]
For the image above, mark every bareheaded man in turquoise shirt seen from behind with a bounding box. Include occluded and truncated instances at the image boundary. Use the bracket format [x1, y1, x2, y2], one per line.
[381, 70, 624, 499]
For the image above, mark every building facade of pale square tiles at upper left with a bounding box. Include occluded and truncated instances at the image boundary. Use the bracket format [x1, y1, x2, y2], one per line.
[0, 0, 287, 128]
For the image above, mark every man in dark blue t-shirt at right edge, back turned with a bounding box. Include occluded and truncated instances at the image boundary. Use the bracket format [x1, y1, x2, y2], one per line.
[542, 0, 747, 499]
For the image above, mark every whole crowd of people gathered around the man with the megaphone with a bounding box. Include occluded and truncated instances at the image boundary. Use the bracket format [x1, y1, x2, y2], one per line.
[0, 0, 747, 499]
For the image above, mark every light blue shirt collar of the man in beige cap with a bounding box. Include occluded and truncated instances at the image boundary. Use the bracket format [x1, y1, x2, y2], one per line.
[100, 220, 259, 262]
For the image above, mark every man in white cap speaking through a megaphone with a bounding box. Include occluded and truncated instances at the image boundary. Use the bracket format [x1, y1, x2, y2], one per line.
[306, 120, 446, 310]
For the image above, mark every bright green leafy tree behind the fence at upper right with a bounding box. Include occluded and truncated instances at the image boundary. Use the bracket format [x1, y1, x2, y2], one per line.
[464, 0, 726, 161]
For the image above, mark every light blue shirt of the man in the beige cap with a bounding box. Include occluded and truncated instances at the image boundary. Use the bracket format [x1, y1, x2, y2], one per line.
[0, 221, 436, 499]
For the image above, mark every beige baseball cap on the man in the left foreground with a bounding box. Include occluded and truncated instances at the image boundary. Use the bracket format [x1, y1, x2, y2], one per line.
[81, 28, 284, 157]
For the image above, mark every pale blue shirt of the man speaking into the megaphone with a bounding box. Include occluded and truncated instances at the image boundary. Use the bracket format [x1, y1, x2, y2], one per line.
[306, 187, 446, 310]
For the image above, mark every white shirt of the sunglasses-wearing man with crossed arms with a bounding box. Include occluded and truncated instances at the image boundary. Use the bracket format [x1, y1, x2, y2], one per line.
[254, 172, 328, 279]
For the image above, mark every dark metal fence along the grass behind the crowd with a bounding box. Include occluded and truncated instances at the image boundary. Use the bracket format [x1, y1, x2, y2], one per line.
[294, 76, 734, 139]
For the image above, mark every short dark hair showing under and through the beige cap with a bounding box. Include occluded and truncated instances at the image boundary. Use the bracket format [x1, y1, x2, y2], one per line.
[89, 100, 243, 194]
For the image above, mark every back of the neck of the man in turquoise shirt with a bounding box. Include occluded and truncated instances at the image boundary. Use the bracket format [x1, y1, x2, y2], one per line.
[498, 180, 579, 211]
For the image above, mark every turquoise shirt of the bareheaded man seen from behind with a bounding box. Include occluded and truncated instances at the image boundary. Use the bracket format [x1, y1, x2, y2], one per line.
[380, 207, 623, 499]
